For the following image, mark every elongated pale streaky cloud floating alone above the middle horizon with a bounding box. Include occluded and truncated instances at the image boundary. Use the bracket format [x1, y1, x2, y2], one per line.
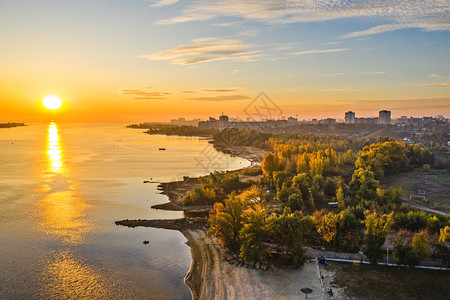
[141, 38, 259, 65]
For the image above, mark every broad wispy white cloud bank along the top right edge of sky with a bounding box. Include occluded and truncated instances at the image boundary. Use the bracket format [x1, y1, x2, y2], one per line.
[158, 0, 450, 38]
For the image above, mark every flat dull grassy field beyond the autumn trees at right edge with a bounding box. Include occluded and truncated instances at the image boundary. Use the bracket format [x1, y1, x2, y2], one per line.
[382, 169, 450, 212]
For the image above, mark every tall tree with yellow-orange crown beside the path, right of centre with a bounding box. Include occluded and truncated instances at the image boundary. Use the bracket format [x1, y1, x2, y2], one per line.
[363, 211, 393, 264]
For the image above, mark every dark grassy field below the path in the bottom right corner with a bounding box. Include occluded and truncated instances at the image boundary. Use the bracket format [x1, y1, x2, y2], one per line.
[323, 262, 450, 300]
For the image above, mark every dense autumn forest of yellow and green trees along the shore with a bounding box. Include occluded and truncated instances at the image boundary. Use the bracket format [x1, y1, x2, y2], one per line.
[183, 129, 450, 266]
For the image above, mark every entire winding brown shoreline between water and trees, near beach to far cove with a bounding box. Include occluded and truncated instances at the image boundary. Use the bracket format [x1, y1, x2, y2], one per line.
[119, 142, 323, 300]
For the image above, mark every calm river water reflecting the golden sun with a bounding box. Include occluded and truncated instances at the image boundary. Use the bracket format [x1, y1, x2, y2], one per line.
[0, 123, 249, 299]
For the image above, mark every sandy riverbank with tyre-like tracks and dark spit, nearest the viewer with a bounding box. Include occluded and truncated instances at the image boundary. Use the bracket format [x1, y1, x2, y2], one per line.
[116, 219, 323, 300]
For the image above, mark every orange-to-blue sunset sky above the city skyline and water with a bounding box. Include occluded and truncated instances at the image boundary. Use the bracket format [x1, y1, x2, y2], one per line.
[0, 0, 450, 122]
